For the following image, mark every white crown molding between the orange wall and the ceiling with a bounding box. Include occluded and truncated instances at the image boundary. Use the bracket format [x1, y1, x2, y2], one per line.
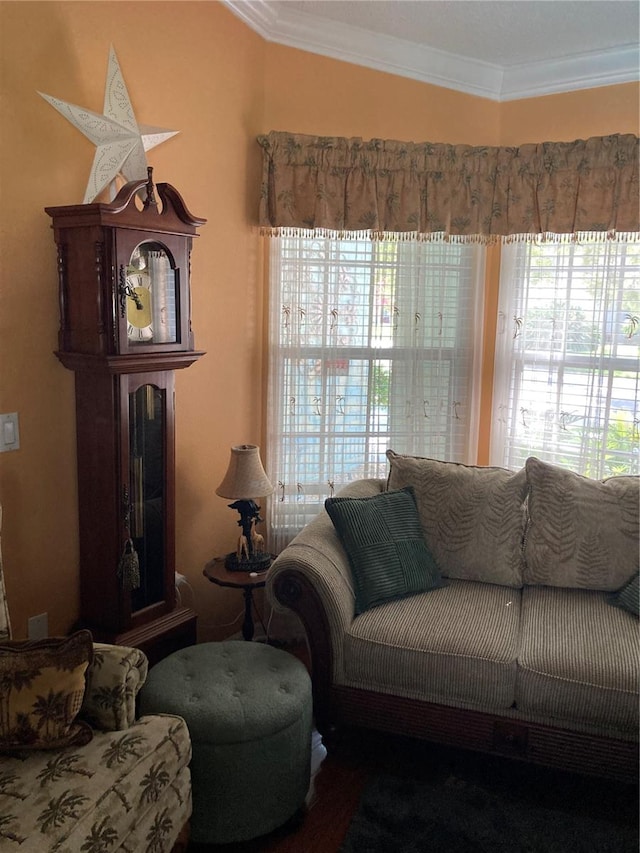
[222, 0, 640, 101]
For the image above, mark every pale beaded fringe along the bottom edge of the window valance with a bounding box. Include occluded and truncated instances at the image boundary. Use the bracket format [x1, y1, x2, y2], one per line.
[260, 226, 640, 246]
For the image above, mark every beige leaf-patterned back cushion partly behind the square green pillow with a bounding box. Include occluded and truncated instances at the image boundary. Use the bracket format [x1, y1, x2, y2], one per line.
[387, 450, 526, 587]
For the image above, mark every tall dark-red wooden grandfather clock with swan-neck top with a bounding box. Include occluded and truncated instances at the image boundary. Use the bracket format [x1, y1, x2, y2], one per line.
[45, 169, 206, 663]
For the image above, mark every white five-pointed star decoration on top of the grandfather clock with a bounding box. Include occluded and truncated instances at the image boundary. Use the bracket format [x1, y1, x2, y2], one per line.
[38, 47, 179, 204]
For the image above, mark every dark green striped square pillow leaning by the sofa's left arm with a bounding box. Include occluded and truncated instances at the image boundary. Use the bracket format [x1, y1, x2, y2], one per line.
[325, 487, 445, 614]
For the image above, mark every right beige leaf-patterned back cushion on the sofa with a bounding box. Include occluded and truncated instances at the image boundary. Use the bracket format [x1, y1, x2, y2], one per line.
[524, 456, 640, 591]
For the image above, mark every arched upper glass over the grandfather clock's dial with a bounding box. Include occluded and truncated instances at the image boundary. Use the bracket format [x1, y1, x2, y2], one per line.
[126, 241, 178, 345]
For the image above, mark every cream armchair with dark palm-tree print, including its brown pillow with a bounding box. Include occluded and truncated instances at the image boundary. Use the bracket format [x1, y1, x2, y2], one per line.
[0, 507, 191, 853]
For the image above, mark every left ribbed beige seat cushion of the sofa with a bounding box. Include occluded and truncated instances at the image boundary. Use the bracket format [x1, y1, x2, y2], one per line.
[336, 580, 520, 711]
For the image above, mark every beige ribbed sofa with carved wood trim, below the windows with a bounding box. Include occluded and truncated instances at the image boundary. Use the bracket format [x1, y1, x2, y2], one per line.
[267, 451, 639, 780]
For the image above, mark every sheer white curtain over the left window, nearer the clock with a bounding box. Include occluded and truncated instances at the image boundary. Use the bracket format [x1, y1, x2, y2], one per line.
[265, 235, 485, 552]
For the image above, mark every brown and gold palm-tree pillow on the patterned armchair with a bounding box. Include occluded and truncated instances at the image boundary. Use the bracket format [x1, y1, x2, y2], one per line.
[0, 631, 93, 751]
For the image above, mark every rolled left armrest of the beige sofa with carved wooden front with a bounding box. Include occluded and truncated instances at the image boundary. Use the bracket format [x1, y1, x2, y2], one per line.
[266, 479, 385, 728]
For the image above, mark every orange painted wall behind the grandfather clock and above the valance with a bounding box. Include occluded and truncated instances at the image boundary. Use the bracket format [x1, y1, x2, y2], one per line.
[0, 2, 638, 639]
